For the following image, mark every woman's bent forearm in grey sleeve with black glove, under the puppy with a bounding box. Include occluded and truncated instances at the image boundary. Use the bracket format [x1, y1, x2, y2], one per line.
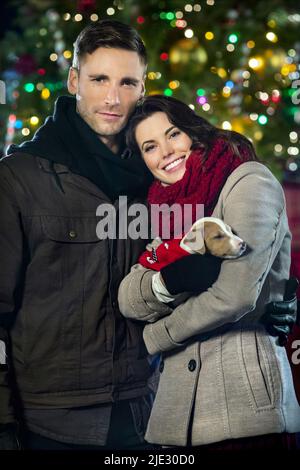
[118, 250, 222, 322]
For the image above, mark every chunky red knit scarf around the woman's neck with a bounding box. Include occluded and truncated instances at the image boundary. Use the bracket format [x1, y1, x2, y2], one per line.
[148, 139, 251, 238]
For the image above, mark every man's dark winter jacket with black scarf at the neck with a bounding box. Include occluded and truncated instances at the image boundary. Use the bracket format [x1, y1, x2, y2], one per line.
[0, 97, 151, 423]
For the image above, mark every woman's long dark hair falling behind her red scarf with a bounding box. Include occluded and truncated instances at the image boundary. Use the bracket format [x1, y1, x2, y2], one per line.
[126, 95, 258, 162]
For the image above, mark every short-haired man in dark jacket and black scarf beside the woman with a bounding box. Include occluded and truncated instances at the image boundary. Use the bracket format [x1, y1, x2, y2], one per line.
[0, 20, 296, 450]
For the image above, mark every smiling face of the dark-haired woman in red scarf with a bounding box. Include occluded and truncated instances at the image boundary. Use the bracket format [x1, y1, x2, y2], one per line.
[135, 112, 192, 186]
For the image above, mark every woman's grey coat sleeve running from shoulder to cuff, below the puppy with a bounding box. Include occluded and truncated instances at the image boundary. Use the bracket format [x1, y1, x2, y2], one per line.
[144, 163, 288, 354]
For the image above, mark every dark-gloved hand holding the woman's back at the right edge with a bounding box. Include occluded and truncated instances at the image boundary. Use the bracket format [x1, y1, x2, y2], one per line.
[261, 277, 299, 346]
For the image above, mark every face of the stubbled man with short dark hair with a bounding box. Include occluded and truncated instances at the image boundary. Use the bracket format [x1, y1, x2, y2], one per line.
[68, 47, 145, 143]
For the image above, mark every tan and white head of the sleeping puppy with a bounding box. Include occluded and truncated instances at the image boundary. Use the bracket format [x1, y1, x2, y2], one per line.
[180, 217, 247, 259]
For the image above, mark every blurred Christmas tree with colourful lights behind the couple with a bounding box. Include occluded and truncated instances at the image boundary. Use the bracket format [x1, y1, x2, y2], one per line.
[0, 0, 300, 177]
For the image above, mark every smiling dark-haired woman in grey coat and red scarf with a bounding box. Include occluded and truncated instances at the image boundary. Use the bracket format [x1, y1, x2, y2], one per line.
[119, 96, 300, 448]
